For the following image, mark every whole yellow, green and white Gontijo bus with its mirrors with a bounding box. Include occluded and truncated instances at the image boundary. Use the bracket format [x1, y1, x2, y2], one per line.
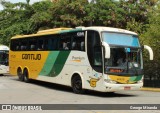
[9, 27, 153, 93]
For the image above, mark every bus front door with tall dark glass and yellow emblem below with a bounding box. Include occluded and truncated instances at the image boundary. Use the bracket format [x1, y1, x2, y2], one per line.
[87, 31, 103, 89]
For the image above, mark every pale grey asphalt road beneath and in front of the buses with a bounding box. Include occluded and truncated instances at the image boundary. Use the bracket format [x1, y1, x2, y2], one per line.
[0, 75, 160, 113]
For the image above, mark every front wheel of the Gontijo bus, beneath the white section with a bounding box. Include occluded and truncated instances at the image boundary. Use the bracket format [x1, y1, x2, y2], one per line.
[72, 75, 84, 94]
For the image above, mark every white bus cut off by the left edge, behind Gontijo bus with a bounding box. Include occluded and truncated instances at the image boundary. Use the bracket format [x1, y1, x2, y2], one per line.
[0, 45, 9, 75]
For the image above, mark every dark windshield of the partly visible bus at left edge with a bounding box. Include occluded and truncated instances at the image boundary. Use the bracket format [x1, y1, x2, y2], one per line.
[0, 50, 9, 65]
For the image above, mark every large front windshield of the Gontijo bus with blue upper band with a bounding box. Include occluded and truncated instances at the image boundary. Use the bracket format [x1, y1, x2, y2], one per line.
[102, 33, 143, 75]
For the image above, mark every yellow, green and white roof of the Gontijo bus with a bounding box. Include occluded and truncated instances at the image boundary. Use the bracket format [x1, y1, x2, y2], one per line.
[11, 26, 137, 39]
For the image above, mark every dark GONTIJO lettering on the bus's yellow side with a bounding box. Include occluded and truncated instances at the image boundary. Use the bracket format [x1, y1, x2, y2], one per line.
[22, 54, 41, 60]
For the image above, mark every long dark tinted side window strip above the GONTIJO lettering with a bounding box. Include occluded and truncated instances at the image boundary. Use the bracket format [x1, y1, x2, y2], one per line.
[11, 31, 85, 51]
